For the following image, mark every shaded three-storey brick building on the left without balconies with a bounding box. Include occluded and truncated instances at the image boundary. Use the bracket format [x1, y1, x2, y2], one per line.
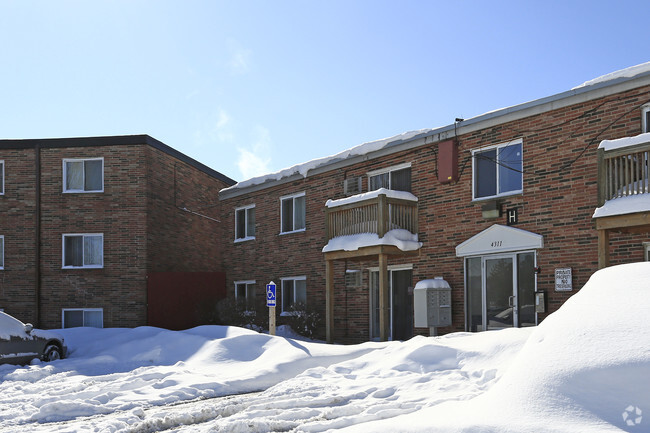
[0, 135, 234, 328]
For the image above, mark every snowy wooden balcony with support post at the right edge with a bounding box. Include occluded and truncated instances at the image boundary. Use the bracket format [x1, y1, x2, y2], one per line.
[593, 133, 650, 268]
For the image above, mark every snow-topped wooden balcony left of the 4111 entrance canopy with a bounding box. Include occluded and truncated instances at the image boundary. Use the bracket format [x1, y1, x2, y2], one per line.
[323, 189, 421, 258]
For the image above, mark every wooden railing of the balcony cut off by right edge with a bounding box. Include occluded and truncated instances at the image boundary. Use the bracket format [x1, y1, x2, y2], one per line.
[598, 142, 650, 206]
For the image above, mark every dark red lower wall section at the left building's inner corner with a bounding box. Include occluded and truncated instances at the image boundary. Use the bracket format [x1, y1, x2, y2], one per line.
[147, 272, 226, 330]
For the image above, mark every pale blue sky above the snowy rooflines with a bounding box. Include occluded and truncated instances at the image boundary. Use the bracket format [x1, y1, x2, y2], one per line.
[0, 0, 650, 180]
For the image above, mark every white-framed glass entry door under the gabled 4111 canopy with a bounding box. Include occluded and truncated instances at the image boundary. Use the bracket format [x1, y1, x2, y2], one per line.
[465, 252, 537, 331]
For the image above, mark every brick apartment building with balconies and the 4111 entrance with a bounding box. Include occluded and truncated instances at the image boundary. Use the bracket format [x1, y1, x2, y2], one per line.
[220, 65, 650, 343]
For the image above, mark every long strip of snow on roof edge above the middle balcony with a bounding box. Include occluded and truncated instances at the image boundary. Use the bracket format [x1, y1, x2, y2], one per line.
[221, 129, 433, 192]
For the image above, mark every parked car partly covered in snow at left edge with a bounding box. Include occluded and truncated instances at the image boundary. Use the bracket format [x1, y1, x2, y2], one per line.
[0, 312, 68, 364]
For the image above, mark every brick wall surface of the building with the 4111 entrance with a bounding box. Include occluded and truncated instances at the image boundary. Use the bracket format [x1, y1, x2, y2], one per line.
[222, 83, 650, 342]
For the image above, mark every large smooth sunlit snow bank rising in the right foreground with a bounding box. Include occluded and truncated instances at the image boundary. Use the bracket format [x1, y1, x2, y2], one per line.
[351, 263, 650, 432]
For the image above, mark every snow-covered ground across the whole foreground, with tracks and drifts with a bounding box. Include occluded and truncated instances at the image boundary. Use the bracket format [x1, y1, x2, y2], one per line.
[0, 263, 650, 433]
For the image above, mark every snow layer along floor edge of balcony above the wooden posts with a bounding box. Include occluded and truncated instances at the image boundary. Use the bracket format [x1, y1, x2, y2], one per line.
[323, 229, 422, 253]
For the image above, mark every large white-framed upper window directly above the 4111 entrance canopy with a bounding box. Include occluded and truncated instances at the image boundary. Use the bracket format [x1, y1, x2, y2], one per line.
[472, 140, 523, 199]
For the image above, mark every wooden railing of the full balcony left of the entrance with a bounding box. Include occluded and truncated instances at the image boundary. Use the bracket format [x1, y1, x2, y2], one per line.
[326, 194, 418, 241]
